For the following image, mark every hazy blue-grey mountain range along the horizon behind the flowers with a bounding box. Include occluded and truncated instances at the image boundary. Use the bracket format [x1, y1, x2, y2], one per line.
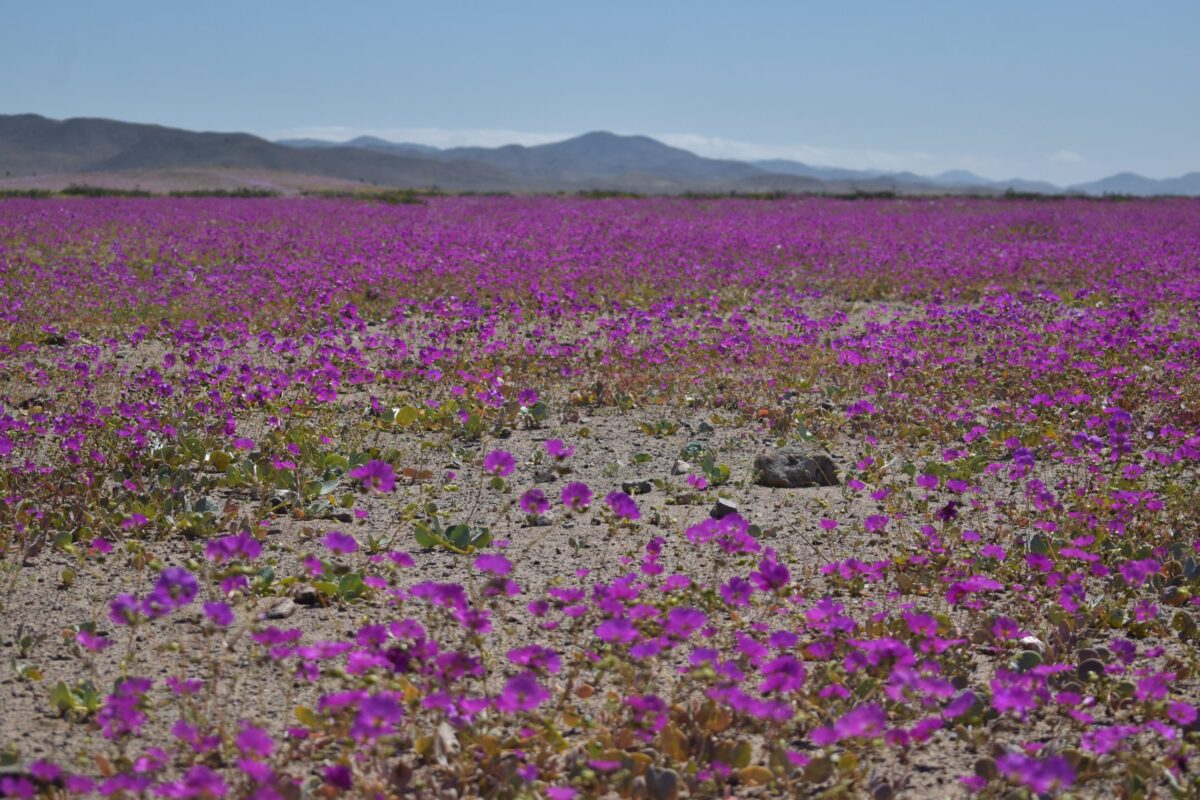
[0, 114, 1200, 197]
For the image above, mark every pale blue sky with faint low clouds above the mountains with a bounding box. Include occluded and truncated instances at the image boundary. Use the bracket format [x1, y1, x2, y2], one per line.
[0, 0, 1200, 182]
